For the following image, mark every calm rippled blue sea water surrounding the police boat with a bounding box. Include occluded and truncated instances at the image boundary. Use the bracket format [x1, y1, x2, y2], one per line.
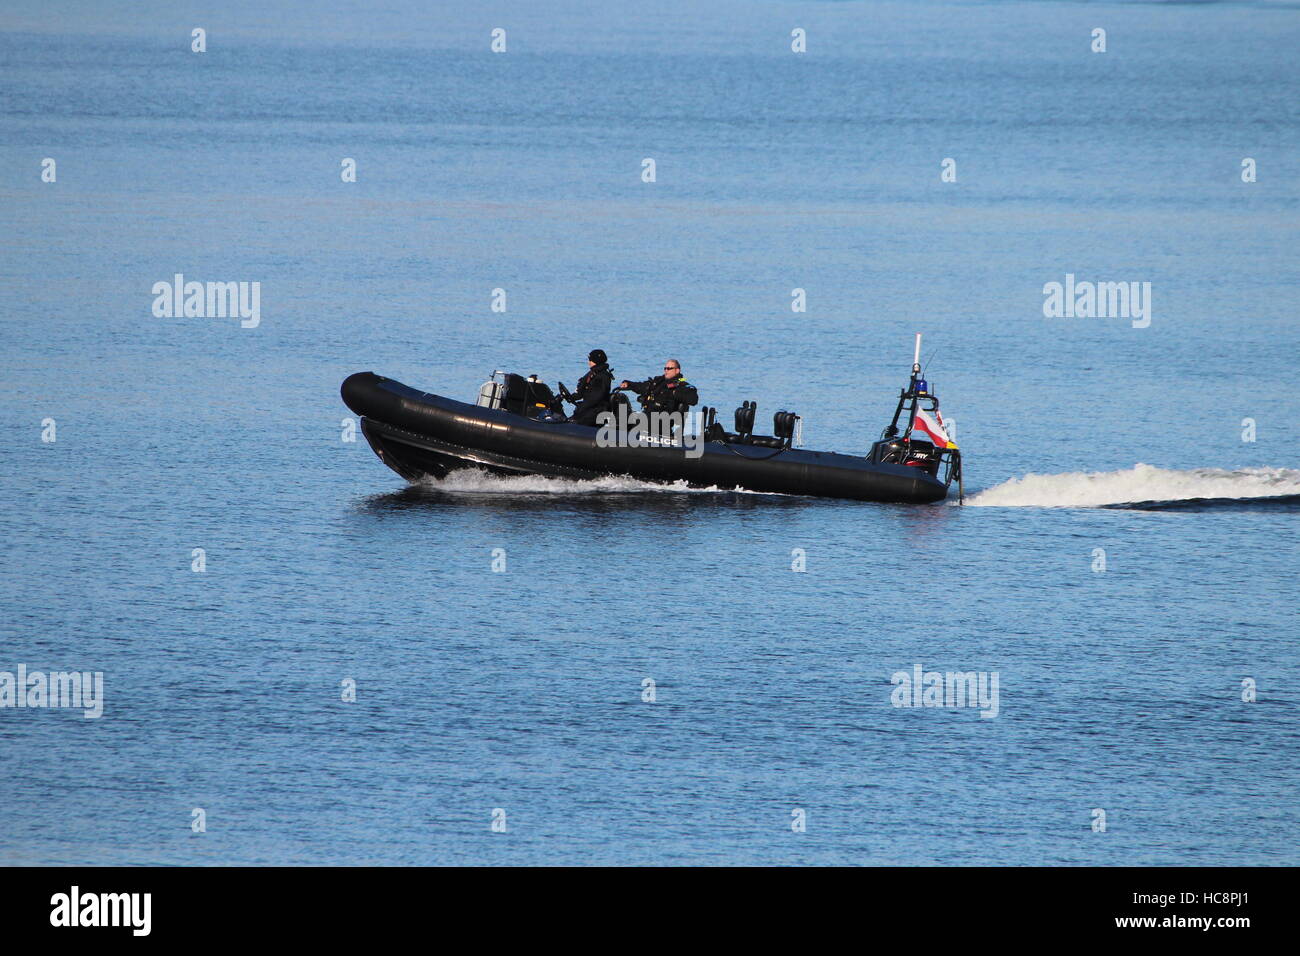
[0, 0, 1300, 864]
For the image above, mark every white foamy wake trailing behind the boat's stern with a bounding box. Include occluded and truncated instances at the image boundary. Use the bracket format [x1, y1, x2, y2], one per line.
[966, 464, 1300, 507]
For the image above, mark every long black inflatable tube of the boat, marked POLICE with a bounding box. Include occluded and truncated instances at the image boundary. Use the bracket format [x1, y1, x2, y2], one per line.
[342, 372, 948, 503]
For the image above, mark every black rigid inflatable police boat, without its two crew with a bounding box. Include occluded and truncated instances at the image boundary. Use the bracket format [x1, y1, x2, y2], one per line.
[342, 336, 961, 503]
